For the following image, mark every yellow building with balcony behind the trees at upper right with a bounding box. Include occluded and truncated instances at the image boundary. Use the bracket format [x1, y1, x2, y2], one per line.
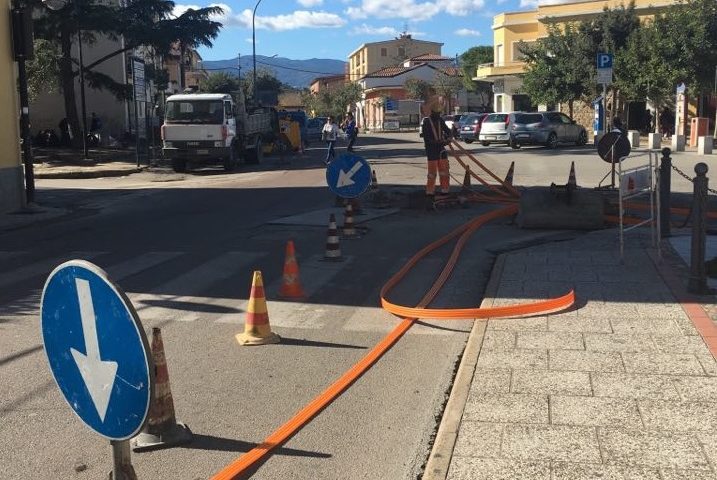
[474, 0, 676, 112]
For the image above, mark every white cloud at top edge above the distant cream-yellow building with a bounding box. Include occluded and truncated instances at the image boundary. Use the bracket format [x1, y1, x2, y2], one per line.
[346, 0, 484, 20]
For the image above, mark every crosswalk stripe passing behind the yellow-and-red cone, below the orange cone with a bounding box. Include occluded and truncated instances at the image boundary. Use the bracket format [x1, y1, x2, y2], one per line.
[215, 255, 353, 328]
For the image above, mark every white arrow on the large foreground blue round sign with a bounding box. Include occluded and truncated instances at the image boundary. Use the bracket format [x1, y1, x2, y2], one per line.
[70, 278, 117, 422]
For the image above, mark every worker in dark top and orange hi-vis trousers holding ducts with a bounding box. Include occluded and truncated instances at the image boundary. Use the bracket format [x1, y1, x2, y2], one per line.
[421, 99, 451, 200]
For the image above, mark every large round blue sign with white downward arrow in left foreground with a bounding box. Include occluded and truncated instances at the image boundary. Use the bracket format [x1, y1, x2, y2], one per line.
[40, 260, 154, 440]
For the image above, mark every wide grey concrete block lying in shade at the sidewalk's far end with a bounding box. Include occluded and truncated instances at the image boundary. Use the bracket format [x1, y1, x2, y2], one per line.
[518, 187, 605, 230]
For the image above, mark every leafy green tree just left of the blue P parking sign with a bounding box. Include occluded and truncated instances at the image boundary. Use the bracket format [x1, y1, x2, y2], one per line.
[519, 24, 595, 118]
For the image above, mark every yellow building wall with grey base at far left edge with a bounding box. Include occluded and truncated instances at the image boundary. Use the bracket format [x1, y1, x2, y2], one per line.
[0, 0, 24, 213]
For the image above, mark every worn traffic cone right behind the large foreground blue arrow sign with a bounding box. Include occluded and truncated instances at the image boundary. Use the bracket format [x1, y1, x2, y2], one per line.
[131, 327, 192, 452]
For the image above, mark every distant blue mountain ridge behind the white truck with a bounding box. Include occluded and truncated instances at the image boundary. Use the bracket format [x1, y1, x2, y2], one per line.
[202, 55, 346, 88]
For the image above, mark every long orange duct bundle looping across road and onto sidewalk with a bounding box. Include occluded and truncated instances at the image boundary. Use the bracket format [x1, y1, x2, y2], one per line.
[212, 205, 575, 480]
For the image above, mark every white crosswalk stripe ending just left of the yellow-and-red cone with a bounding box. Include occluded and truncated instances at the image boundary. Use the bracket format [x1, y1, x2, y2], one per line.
[129, 252, 263, 322]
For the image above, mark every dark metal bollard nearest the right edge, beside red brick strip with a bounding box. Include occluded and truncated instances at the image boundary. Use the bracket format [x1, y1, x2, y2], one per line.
[687, 163, 709, 294]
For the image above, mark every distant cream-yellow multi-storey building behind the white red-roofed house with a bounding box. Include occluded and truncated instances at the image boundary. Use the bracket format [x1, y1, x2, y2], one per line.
[349, 33, 443, 82]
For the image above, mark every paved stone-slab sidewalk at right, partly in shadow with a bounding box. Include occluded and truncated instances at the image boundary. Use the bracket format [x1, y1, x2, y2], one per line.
[424, 230, 717, 480]
